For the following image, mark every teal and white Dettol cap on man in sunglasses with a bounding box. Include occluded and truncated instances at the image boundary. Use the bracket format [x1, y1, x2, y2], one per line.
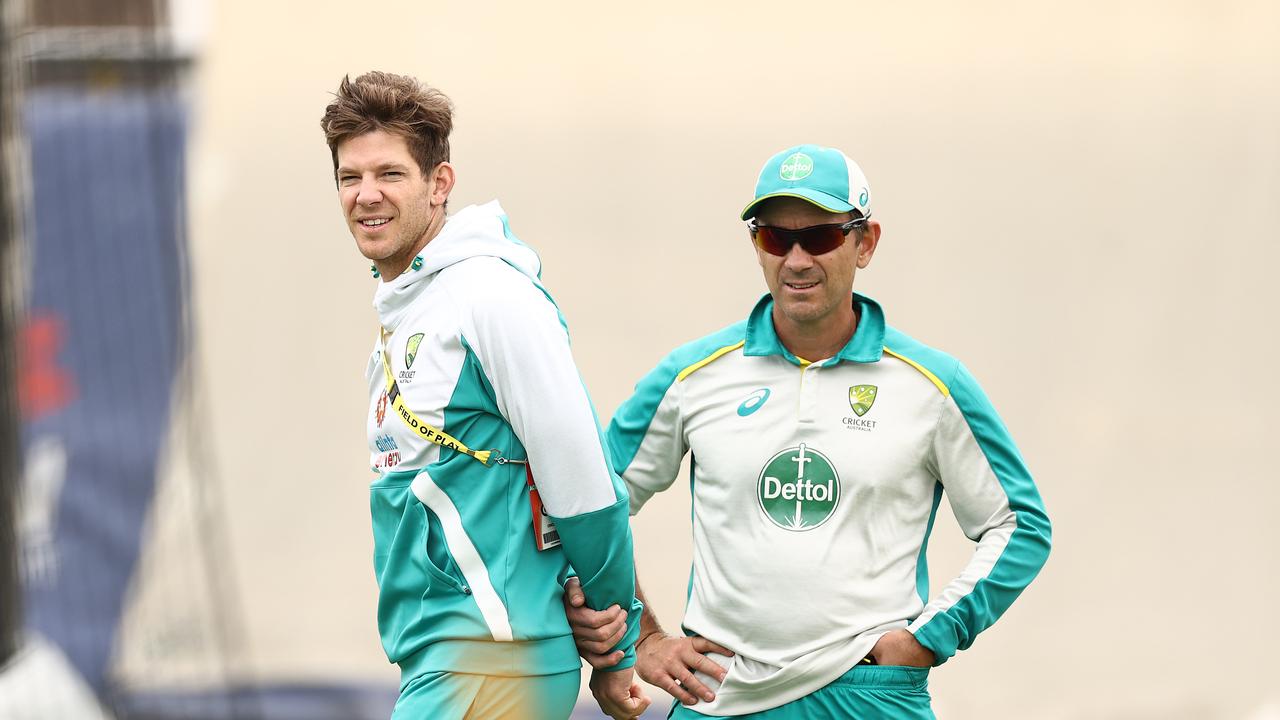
[742, 145, 872, 220]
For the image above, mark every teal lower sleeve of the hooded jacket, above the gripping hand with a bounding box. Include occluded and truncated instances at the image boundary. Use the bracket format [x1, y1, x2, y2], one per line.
[552, 491, 644, 671]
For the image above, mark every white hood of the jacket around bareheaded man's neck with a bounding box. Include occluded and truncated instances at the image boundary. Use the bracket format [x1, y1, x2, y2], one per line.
[374, 200, 543, 331]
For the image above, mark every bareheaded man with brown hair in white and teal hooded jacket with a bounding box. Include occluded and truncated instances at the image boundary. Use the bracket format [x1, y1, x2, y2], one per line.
[321, 72, 649, 720]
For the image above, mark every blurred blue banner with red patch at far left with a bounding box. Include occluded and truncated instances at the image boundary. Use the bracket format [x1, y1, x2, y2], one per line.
[19, 87, 187, 692]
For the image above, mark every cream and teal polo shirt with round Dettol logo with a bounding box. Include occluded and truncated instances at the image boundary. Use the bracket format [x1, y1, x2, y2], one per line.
[608, 295, 1050, 715]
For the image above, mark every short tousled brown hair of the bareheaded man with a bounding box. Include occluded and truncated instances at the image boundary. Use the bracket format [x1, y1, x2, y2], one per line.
[320, 70, 453, 176]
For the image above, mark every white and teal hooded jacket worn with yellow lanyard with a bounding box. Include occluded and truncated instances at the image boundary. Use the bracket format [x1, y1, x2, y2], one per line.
[366, 202, 640, 678]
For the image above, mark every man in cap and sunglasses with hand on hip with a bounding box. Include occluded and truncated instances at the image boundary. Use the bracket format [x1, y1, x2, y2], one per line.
[566, 145, 1050, 720]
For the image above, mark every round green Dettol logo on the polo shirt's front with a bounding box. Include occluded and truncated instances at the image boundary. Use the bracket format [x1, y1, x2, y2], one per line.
[756, 443, 840, 532]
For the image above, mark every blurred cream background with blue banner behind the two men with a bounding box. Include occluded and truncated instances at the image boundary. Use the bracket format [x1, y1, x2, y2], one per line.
[0, 0, 1280, 720]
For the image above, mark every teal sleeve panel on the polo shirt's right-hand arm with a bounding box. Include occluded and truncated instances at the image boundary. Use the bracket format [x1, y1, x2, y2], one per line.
[915, 365, 1052, 665]
